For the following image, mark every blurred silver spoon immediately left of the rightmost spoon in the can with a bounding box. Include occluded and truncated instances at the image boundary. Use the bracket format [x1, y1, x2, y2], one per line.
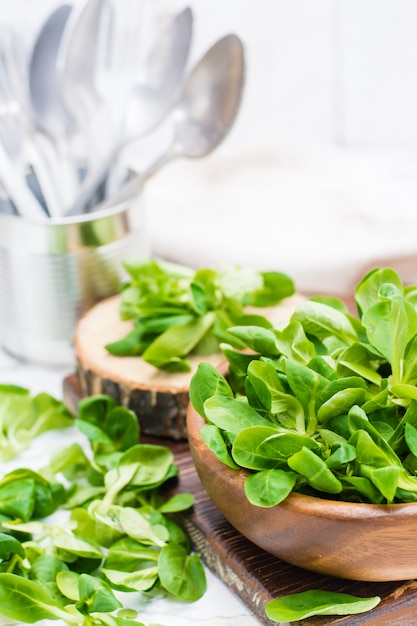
[67, 7, 193, 215]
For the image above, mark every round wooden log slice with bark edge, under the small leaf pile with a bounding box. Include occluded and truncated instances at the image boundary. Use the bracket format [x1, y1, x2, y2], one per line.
[74, 295, 303, 440]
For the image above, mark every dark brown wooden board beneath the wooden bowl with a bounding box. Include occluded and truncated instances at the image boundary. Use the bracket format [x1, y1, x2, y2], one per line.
[64, 376, 417, 626]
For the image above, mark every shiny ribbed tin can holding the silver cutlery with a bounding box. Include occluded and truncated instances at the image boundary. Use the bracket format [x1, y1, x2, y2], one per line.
[0, 197, 149, 366]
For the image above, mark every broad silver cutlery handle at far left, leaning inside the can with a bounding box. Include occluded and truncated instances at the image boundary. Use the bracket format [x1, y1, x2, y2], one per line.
[0, 144, 45, 219]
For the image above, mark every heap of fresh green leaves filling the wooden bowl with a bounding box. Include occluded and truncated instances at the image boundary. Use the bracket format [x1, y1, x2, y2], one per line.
[190, 269, 417, 507]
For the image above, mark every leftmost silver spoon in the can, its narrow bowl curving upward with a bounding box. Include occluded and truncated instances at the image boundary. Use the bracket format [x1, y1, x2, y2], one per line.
[28, 4, 78, 208]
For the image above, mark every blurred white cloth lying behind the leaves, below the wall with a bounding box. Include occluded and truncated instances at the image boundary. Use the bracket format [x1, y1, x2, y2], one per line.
[145, 146, 417, 294]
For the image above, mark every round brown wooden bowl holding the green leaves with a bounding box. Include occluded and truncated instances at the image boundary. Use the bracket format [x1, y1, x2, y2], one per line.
[187, 405, 417, 581]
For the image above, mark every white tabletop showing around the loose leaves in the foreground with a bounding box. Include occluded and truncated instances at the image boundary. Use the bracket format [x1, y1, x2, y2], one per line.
[0, 348, 260, 626]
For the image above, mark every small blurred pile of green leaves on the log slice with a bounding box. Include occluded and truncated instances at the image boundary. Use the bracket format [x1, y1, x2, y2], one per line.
[106, 261, 294, 372]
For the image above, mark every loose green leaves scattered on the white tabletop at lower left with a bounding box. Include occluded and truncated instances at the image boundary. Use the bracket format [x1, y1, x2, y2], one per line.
[0, 396, 206, 626]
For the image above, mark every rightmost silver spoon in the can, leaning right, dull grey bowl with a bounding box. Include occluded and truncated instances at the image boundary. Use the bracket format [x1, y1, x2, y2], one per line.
[92, 34, 245, 211]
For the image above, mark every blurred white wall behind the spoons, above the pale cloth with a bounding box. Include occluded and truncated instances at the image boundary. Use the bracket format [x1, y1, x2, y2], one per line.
[8, 0, 417, 150]
